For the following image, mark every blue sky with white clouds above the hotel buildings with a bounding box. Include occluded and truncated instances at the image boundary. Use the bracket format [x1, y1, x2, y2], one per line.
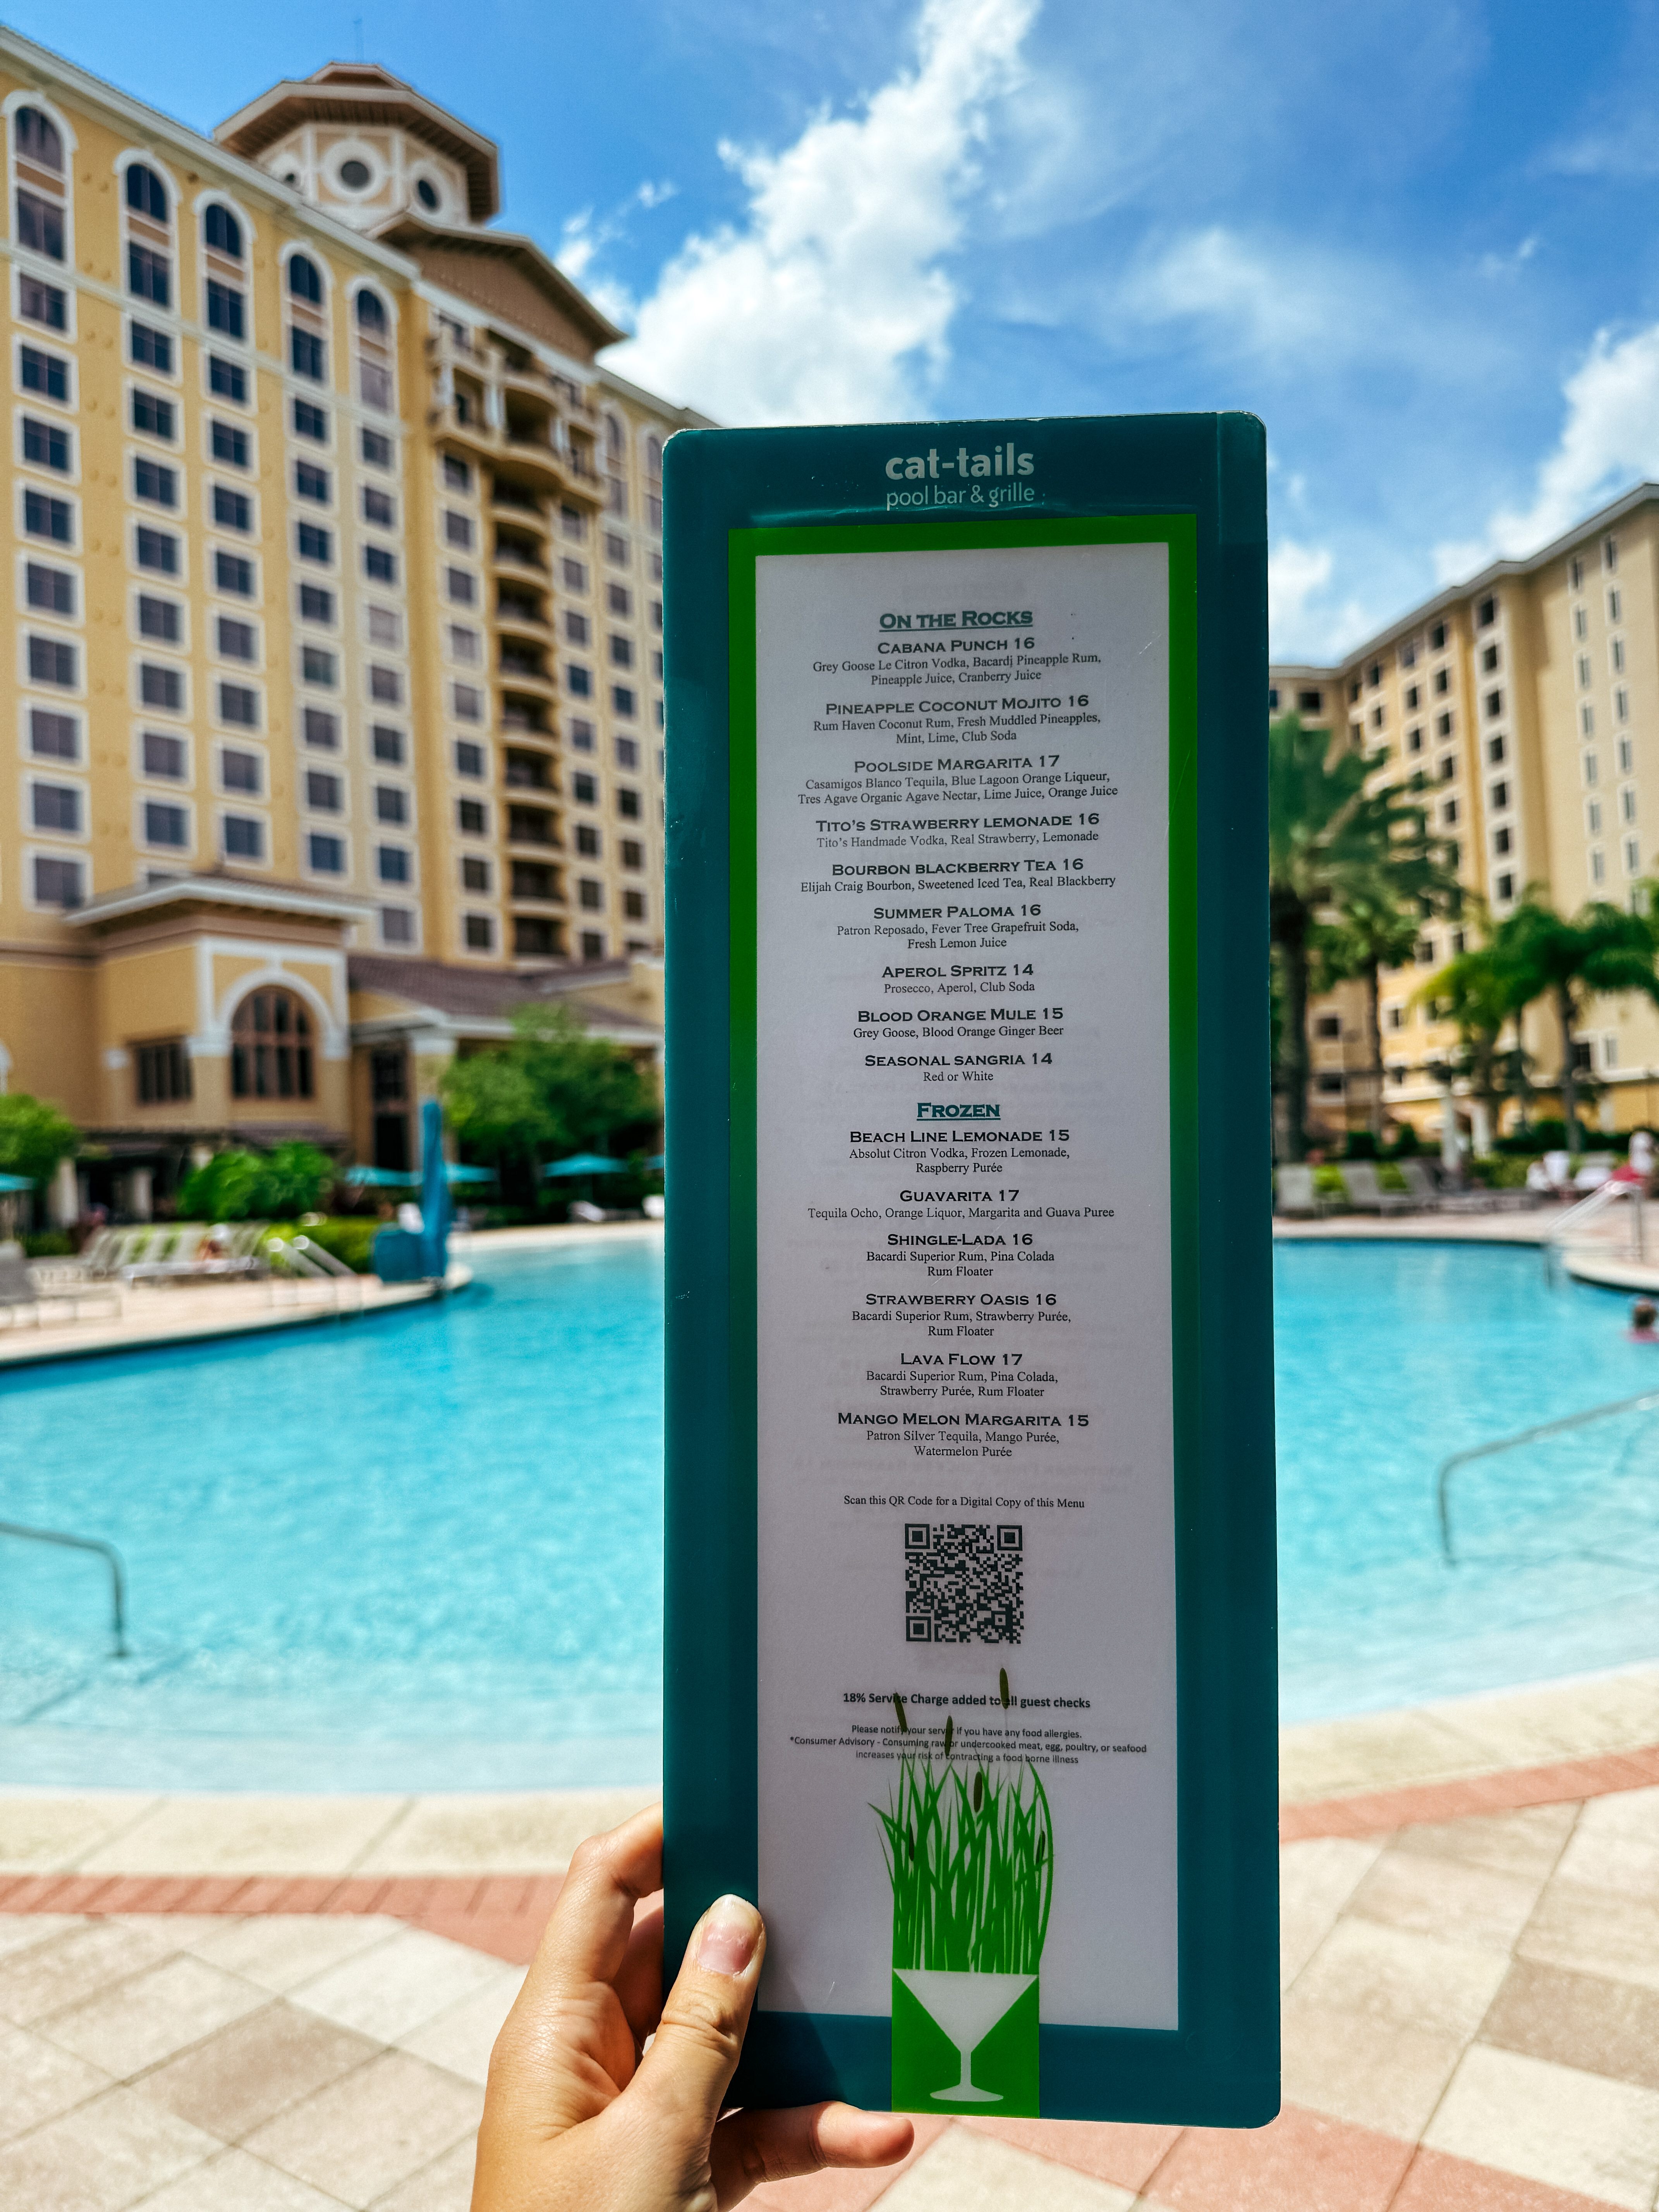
[29, 0, 1659, 657]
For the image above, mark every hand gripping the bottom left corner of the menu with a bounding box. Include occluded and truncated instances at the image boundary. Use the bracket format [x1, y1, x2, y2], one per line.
[473, 1807, 914, 2212]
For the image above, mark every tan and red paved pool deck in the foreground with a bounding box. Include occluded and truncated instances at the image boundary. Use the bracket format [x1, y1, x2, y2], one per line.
[0, 1666, 1659, 2212]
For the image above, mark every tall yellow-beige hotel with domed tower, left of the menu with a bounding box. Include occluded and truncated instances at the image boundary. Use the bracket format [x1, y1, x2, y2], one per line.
[0, 31, 703, 1212]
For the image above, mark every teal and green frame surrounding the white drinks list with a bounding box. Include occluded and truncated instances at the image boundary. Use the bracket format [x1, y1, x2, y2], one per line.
[664, 416, 1279, 2126]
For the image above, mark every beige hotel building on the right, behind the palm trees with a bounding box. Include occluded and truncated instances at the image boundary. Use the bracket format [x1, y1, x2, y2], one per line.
[1267, 484, 1659, 1150]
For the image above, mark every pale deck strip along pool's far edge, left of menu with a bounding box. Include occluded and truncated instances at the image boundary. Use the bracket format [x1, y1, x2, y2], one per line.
[0, 1221, 661, 1371]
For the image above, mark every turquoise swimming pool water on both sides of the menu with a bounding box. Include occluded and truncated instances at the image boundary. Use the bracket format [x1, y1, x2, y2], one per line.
[0, 1237, 1659, 1790]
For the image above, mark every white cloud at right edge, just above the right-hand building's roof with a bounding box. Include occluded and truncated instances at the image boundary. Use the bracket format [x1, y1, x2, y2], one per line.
[1433, 323, 1659, 584]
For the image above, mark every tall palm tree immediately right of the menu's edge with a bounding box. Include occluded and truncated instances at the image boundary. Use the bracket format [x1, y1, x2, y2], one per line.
[1267, 714, 1455, 1159]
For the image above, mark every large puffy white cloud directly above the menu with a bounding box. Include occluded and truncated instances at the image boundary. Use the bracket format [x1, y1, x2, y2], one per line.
[608, 0, 1037, 425]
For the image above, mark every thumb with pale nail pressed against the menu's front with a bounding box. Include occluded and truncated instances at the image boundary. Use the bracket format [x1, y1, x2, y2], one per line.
[635, 1898, 765, 2148]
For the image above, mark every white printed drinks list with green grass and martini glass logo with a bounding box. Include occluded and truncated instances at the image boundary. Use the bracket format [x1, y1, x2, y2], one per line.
[752, 542, 1179, 2070]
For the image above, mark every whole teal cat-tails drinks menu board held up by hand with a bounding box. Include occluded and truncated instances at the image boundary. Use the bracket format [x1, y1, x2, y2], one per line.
[664, 414, 1279, 2126]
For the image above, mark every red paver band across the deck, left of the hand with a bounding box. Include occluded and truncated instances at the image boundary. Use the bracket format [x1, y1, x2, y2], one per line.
[0, 1874, 564, 1966]
